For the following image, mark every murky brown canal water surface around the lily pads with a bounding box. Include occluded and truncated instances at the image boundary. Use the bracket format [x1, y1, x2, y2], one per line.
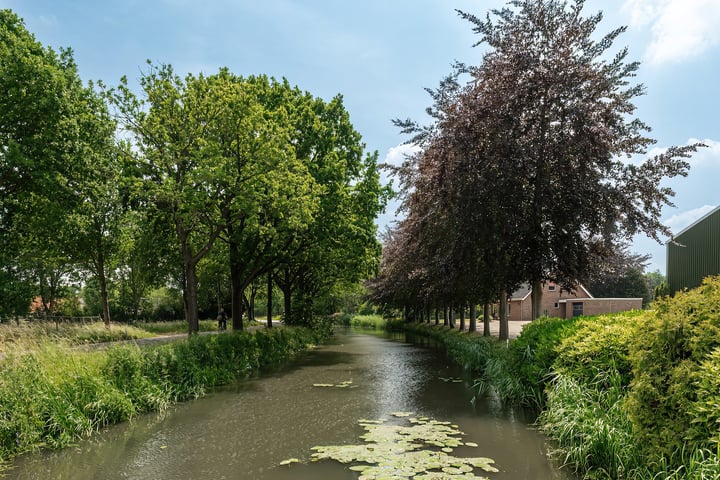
[8, 333, 566, 480]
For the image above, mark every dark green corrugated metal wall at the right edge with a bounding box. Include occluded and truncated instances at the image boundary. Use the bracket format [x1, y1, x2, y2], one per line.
[667, 208, 720, 293]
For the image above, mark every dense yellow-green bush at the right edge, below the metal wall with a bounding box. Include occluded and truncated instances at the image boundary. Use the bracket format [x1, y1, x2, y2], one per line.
[628, 277, 720, 463]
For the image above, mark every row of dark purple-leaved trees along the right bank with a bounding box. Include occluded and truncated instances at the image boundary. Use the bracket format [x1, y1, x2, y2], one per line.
[371, 0, 698, 337]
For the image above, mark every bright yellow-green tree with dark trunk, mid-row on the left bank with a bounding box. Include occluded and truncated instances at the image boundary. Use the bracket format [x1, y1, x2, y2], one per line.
[211, 73, 322, 330]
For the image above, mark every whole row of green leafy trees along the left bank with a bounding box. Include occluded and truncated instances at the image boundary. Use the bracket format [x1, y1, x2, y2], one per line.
[0, 10, 388, 333]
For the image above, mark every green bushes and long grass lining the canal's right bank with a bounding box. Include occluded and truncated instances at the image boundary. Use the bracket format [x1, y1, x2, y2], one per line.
[390, 278, 720, 480]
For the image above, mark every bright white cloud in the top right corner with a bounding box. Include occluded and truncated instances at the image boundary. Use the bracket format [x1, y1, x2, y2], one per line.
[622, 0, 720, 65]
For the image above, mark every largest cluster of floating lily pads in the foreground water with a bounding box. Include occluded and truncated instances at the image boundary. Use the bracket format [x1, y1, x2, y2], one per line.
[312, 412, 498, 480]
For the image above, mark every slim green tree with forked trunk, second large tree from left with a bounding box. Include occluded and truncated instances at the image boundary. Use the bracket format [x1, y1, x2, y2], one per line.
[112, 64, 228, 334]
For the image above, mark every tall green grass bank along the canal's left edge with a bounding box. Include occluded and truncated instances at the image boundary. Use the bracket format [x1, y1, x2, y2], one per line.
[0, 320, 331, 470]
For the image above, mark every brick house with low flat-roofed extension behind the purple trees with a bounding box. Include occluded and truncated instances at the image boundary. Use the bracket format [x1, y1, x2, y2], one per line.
[507, 282, 642, 321]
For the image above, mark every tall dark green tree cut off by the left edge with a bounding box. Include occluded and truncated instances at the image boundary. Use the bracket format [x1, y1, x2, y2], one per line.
[0, 10, 105, 311]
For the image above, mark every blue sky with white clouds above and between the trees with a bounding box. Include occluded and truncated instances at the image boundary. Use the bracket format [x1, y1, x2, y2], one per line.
[7, 0, 720, 273]
